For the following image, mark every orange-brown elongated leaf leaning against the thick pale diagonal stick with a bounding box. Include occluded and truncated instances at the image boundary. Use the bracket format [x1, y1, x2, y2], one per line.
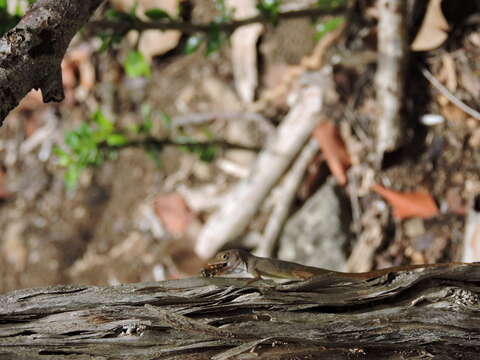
[313, 121, 351, 185]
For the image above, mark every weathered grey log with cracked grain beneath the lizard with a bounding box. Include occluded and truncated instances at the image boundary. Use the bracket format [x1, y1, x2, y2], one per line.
[0, 264, 480, 360]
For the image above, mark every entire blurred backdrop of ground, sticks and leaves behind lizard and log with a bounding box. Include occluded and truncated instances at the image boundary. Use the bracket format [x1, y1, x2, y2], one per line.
[0, 0, 480, 292]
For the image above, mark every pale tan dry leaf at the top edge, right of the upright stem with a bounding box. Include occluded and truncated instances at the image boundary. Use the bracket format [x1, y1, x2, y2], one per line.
[411, 0, 449, 51]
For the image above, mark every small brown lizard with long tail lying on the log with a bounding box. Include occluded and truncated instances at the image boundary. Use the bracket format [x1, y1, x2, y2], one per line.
[202, 249, 472, 283]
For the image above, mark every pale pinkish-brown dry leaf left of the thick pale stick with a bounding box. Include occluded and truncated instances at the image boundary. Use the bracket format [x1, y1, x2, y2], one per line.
[154, 193, 193, 237]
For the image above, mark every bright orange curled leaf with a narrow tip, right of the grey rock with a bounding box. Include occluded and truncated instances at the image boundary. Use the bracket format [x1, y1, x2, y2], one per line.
[372, 184, 439, 219]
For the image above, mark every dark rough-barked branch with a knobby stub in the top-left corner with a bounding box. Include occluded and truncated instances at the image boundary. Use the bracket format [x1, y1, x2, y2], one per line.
[0, 0, 102, 125]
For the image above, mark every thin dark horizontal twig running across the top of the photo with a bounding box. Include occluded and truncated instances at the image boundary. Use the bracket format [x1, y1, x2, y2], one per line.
[89, 7, 345, 34]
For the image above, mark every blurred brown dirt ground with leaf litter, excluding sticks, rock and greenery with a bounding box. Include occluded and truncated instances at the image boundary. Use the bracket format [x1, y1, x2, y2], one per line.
[0, 0, 480, 292]
